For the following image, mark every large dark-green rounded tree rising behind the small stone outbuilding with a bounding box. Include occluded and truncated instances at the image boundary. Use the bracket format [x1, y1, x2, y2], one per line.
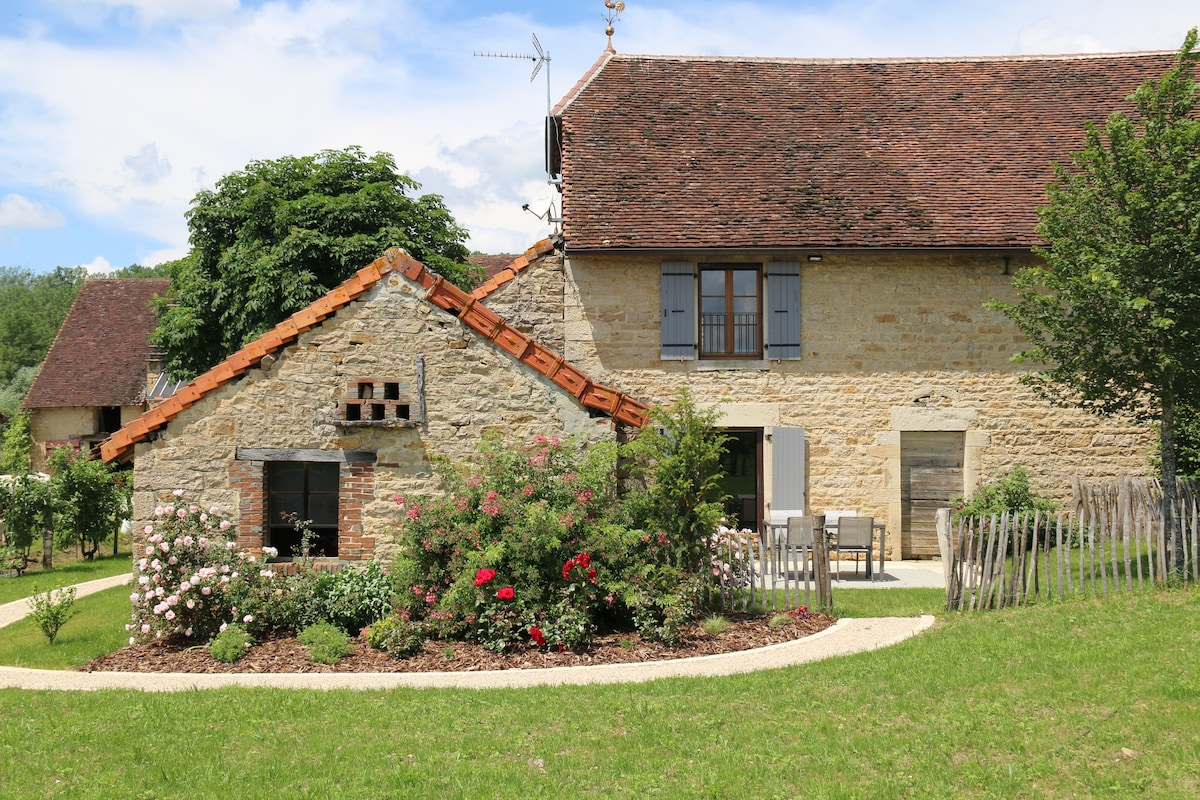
[155, 148, 478, 378]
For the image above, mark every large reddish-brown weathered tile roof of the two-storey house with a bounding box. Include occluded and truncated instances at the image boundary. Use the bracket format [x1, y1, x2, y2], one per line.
[553, 52, 1175, 251]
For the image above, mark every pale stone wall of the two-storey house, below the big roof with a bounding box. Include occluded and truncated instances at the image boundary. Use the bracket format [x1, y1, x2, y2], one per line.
[564, 254, 1152, 556]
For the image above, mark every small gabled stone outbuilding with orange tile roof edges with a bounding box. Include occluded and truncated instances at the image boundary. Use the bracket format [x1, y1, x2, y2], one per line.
[102, 241, 647, 560]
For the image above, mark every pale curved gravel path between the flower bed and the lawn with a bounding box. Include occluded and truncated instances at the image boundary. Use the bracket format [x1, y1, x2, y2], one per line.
[0, 576, 934, 692]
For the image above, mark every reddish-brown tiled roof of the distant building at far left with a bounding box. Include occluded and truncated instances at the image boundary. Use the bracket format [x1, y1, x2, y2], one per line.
[23, 278, 170, 409]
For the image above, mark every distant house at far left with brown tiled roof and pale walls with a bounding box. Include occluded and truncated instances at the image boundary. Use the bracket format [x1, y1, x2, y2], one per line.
[22, 278, 170, 471]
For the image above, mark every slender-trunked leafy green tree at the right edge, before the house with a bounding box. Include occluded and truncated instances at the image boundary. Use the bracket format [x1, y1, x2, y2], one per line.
[989, 29, 1200, 570]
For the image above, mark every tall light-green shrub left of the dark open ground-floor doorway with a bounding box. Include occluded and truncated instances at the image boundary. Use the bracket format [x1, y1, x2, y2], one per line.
[625, 387, 727, 572]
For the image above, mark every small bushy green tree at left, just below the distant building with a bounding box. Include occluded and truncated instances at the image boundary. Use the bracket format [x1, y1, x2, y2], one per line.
[49, 447, 130, 560]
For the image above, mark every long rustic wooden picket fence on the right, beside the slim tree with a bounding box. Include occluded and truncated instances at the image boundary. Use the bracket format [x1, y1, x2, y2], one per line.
[937, 477, 1200, 610]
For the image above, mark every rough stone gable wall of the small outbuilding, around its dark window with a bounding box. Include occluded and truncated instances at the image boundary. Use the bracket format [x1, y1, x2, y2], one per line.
[134, 275, 612, 558]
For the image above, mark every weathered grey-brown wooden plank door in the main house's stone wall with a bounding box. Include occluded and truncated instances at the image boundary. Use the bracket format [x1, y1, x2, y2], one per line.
[900, 431, 964, 558]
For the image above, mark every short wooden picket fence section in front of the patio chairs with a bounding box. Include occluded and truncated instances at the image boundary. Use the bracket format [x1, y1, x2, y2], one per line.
[707, 525, 833, 612]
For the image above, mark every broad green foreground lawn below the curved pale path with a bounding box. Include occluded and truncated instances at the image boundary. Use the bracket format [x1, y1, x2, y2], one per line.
[0, 588, 1200, 799]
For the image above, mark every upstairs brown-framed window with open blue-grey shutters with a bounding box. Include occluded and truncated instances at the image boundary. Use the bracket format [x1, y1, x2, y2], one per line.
[661, 261, 800, 361]
